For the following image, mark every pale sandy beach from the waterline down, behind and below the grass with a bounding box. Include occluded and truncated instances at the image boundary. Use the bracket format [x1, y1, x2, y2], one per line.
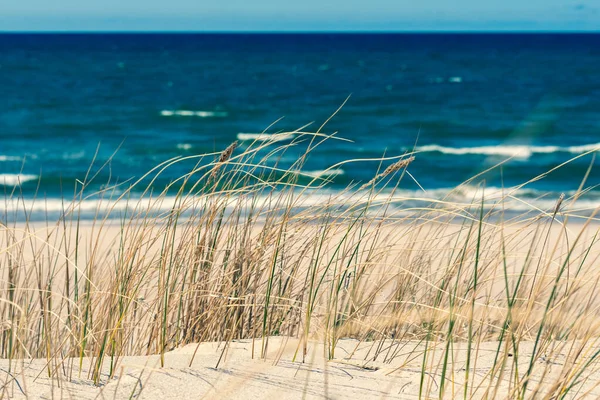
[0, 217, 600, 399]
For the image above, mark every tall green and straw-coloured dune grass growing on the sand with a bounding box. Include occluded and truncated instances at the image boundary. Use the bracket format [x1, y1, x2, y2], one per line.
[0, 130, 600, 399]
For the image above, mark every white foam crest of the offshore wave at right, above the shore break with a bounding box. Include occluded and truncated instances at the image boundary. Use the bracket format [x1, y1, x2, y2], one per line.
[417, 143, 600, 158]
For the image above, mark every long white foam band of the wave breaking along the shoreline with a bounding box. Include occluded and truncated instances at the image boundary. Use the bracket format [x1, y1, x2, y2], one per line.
[0, 184, 600, 219]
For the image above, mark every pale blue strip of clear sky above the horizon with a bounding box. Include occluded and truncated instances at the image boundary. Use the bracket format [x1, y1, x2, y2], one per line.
[0, 0, 600, 31]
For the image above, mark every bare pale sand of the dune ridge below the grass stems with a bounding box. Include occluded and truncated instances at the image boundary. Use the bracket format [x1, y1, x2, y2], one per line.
[0, 338, 600, 400]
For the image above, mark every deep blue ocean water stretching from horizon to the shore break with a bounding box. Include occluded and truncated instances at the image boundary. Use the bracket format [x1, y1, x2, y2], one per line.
[0, 34, 600, 220]
